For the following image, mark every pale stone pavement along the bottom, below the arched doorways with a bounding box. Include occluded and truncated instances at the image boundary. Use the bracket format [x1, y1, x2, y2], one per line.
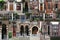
[0, 33, 50, 40]
